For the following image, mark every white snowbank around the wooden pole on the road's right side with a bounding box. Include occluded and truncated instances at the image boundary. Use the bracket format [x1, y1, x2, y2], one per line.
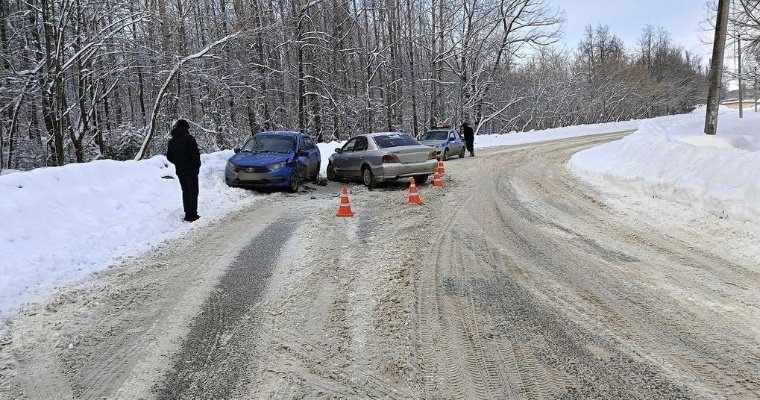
[570, 107, 760, 221]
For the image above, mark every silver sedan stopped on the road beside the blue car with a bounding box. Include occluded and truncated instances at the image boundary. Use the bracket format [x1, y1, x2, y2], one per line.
[327, 132, 438, 188]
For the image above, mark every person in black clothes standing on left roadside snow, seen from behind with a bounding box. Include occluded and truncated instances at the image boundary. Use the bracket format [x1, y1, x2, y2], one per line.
[166, 119, 201, 222]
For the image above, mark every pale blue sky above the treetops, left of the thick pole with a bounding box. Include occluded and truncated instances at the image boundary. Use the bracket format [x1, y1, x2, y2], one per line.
[554, 0, 714, 64]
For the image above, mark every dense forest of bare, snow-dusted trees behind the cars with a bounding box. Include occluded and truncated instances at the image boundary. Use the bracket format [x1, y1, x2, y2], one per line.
[0, 0, 760, 170]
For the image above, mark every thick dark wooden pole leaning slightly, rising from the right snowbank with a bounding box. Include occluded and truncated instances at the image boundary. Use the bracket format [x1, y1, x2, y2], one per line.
[705, 0, 730, 135]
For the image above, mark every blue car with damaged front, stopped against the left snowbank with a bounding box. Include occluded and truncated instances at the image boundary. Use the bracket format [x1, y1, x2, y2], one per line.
[224, 131, 321, 193]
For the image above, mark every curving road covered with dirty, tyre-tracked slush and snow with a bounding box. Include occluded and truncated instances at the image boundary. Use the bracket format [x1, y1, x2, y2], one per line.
[0, 134, 760, 398]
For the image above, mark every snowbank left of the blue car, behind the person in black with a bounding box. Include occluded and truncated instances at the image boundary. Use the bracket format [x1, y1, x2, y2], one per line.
[0, 150, 258, 314]
